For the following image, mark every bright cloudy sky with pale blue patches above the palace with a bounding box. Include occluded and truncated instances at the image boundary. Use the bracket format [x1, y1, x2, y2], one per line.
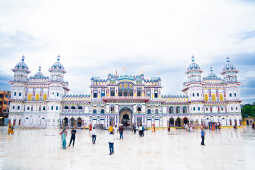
[0, 0, 255, 103]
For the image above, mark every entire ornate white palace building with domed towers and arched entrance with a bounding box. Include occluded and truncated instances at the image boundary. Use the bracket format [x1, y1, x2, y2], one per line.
[10, 57, 241, 128]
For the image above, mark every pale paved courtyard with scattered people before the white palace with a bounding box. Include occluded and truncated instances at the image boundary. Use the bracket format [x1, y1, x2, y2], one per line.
[0, 127, 255, 170]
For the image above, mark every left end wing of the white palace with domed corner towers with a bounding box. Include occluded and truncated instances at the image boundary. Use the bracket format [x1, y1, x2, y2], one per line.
[9, 57, 69, 128]
